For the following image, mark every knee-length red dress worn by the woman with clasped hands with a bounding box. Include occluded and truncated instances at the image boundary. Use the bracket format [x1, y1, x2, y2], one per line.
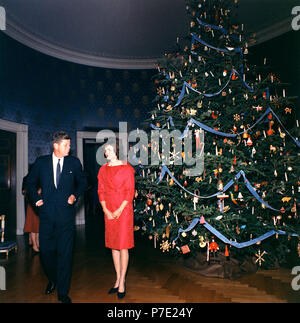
[98, 163, 135, 250]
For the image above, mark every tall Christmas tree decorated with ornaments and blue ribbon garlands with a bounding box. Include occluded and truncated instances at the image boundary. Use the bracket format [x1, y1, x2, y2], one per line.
[135, 0, 300, 276]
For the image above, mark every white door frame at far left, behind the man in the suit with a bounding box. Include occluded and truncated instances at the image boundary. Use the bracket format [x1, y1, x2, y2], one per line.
[0, 119, 28, 235]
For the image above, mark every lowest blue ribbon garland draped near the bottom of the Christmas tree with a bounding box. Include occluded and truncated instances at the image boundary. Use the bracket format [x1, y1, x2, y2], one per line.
[174, 218, 298, 249]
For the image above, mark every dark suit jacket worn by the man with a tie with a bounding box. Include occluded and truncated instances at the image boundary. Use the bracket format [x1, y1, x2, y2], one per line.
[26, 154, 87, 220]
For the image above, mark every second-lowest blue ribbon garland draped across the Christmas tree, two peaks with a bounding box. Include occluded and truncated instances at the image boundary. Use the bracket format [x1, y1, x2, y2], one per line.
[156, 165, 281, 212]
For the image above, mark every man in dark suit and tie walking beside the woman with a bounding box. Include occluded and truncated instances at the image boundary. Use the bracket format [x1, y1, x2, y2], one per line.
[27, 131, 87, 303]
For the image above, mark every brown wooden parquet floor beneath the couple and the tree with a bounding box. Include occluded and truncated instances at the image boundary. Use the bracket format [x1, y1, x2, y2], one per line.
[0, 218, 300, 303]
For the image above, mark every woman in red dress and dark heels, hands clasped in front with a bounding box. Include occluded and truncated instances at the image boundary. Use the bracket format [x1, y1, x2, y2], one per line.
[98, 141, 135, 298]
